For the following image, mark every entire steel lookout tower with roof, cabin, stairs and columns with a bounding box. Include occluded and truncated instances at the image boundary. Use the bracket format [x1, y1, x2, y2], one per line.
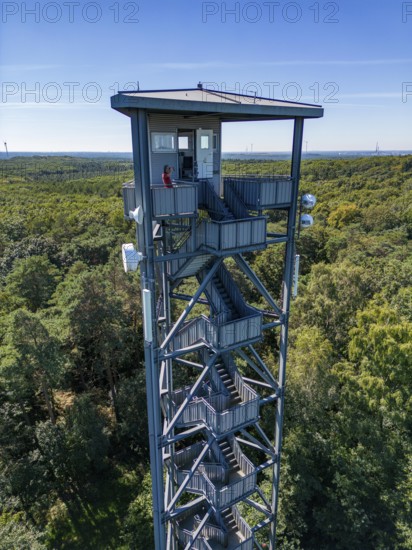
[111, 87, 323, 550]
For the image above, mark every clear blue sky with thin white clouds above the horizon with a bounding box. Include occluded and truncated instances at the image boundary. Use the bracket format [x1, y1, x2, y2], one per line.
[0, 0, 412, 151]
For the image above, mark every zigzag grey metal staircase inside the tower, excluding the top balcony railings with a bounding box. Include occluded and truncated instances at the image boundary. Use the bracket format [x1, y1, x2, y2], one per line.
[143, 181, 288, 550]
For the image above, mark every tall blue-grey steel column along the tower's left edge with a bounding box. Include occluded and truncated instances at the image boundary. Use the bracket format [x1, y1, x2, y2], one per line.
[131, 109, 166, 550]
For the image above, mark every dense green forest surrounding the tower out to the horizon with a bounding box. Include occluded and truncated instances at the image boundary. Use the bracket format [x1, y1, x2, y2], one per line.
[0, 156, 412, 550]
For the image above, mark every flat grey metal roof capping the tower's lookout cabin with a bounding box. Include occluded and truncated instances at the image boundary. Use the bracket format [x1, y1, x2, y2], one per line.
[111, 88, 323, 121]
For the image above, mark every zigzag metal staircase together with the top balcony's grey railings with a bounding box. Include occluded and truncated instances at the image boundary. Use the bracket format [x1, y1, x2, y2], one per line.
[120, 166, 304, 550]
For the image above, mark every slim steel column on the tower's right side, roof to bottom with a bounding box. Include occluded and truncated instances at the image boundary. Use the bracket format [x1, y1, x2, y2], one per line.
[270, 117, 303, 550]
